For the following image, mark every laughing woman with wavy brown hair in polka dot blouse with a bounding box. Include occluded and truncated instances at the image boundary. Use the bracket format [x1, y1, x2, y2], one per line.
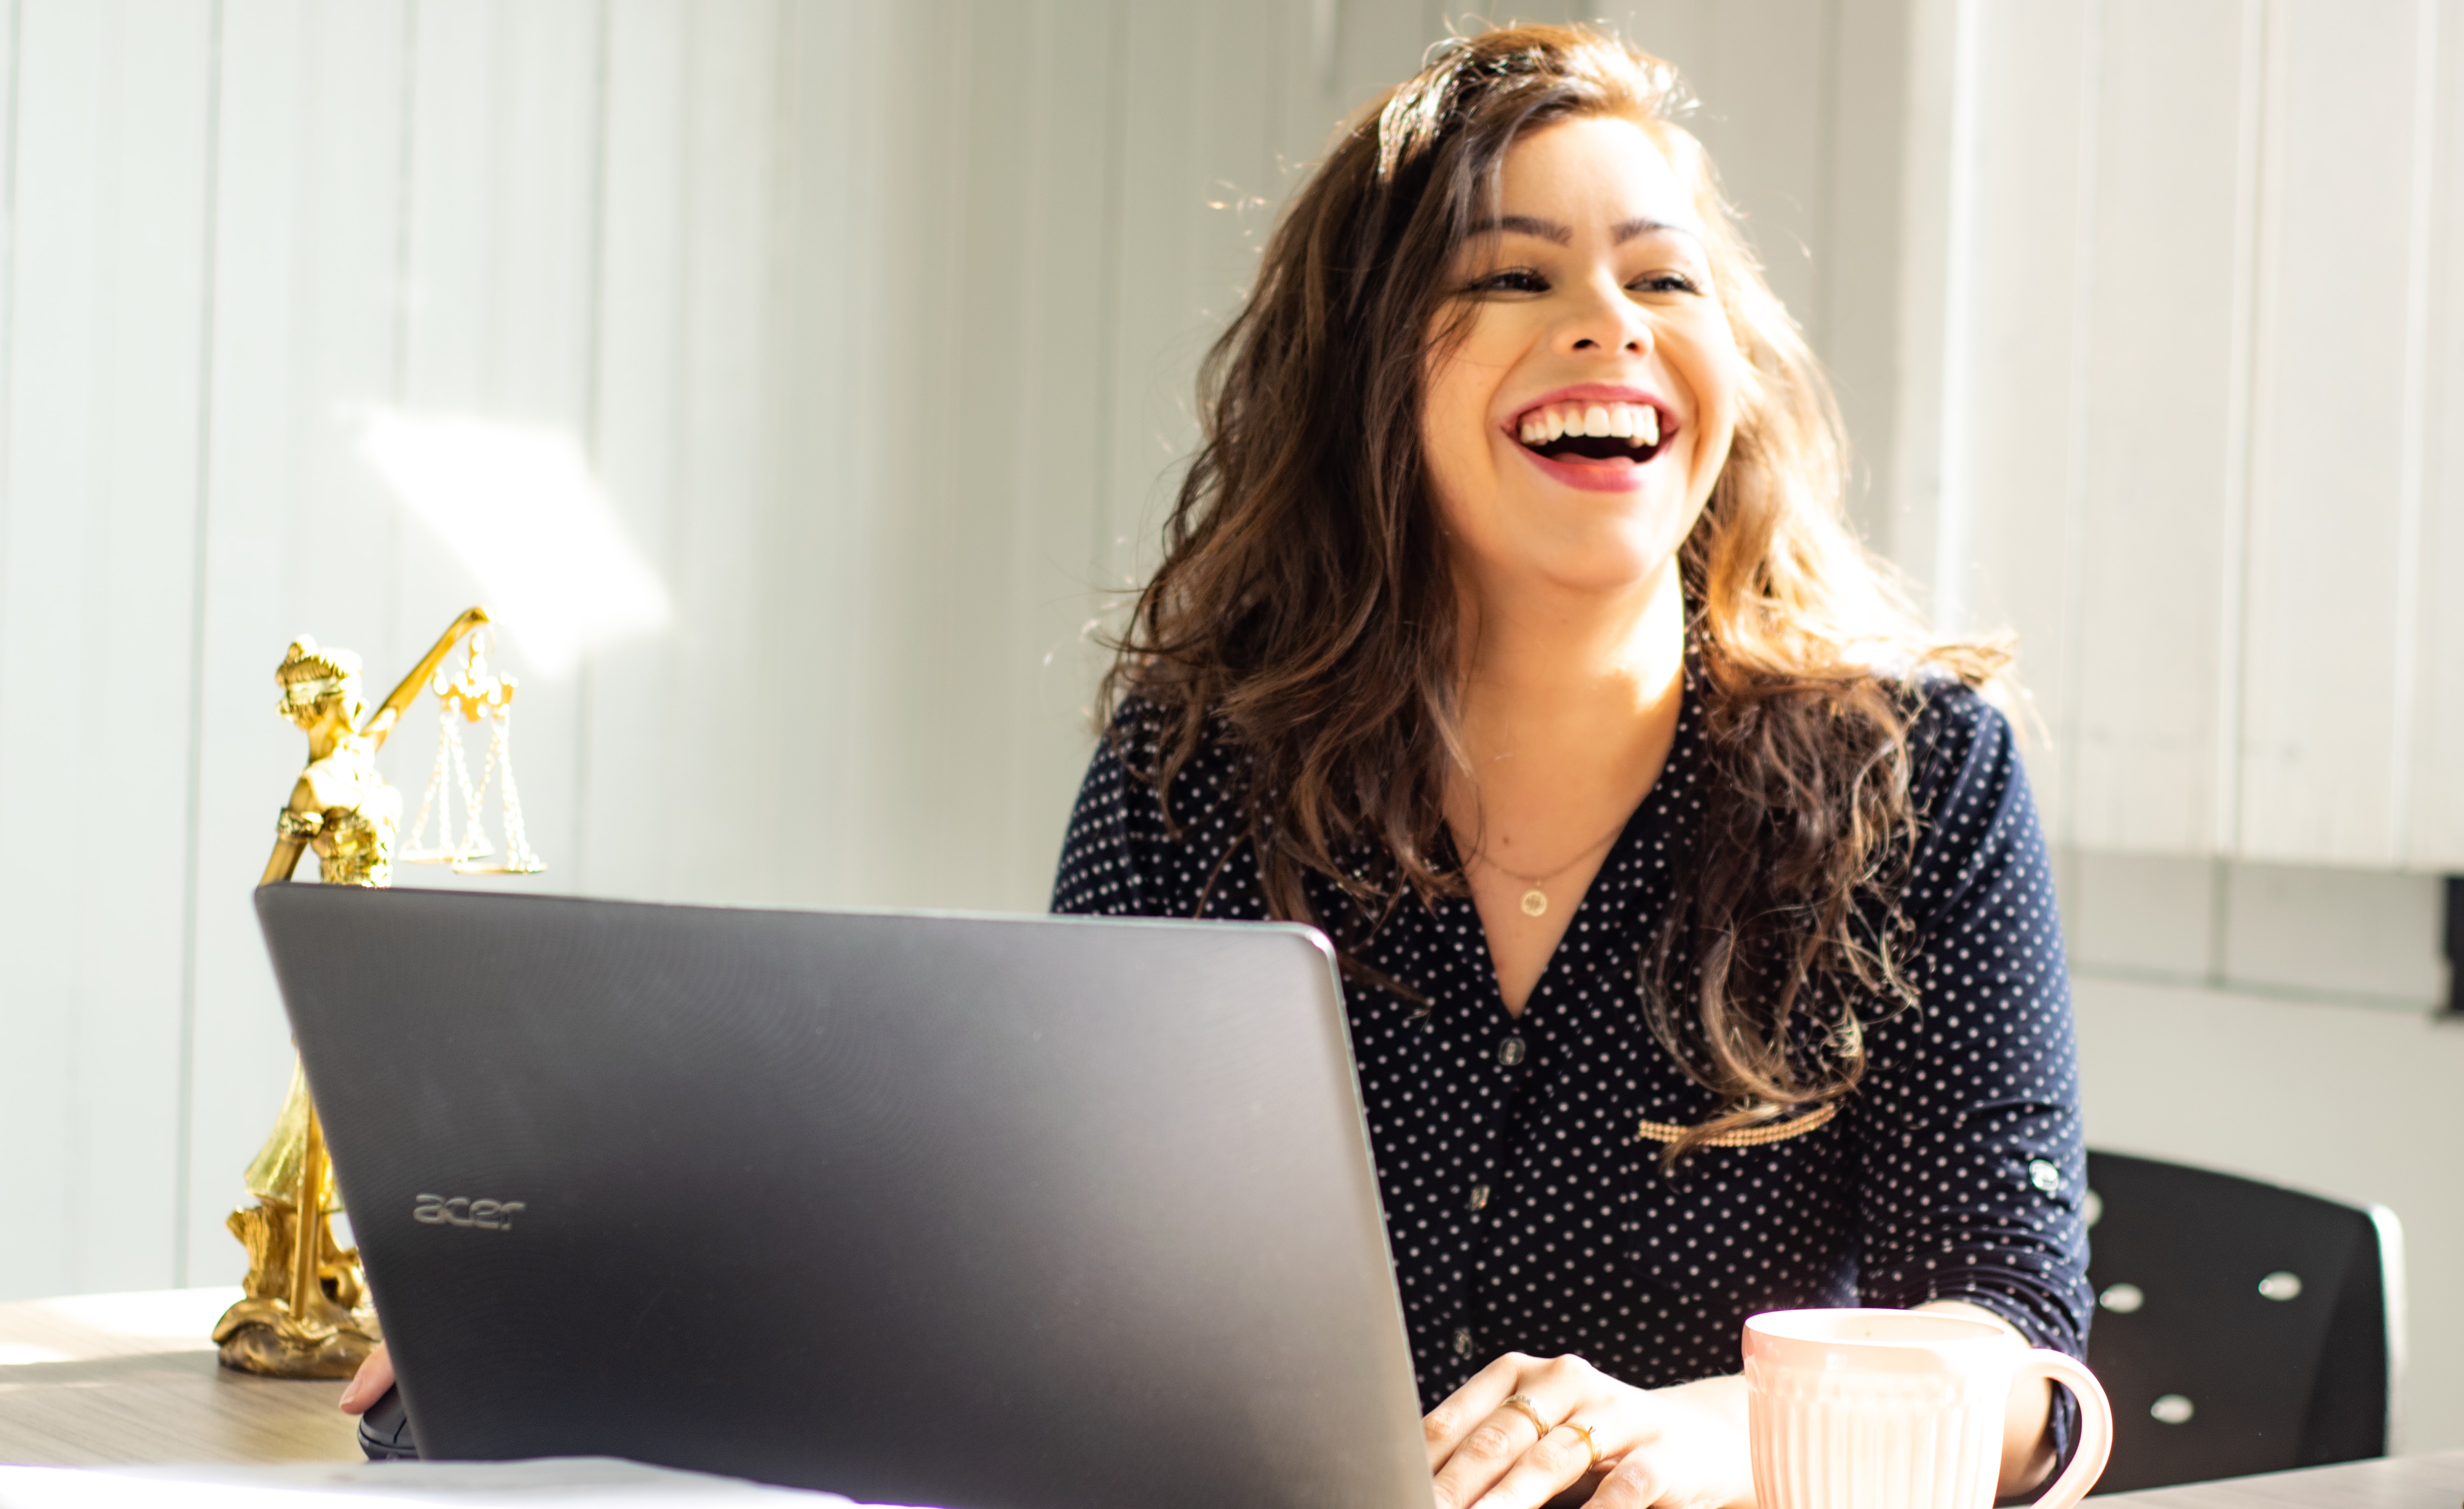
[1055, 27, 2087, 1509]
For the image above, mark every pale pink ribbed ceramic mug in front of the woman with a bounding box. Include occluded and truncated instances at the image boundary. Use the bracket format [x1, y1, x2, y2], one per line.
[1745, 1309, 2114, 1509]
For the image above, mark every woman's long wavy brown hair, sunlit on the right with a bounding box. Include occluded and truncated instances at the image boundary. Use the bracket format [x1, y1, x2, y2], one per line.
[1101, 27, 2006, 1162]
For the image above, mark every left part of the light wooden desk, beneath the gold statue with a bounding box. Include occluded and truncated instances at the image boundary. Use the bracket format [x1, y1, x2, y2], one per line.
[0, 1287, 360, 1467]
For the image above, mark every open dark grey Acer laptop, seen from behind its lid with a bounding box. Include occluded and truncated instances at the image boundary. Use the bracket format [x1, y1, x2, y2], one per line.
[256, 885, 1429, 1509]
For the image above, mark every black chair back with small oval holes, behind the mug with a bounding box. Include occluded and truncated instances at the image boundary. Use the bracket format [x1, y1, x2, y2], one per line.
[2087, 1152, 2405, 1492]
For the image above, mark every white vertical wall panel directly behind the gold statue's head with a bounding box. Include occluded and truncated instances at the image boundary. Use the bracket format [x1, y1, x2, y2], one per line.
[180, 0, 416, 1282]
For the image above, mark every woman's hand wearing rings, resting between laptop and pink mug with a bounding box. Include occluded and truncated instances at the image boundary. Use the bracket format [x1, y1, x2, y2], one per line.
[1419, 1351, 1754, 1509]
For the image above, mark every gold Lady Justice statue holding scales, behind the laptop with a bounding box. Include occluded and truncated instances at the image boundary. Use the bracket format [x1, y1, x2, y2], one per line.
[214, 609, 545, 1378]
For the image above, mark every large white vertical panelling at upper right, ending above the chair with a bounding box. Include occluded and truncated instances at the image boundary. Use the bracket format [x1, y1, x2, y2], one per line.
[1890, 0, 2464, 870]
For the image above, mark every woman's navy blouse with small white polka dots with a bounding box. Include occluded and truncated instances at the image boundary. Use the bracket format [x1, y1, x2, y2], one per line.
[1052, 678, 2089, 1410]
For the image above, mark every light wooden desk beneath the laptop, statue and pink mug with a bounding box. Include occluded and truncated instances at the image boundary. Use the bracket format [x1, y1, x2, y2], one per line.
[0, 1290, 2464, 1509]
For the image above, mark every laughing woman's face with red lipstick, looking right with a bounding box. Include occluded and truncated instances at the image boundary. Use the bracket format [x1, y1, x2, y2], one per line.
[1422, 116, 1745, 597]
